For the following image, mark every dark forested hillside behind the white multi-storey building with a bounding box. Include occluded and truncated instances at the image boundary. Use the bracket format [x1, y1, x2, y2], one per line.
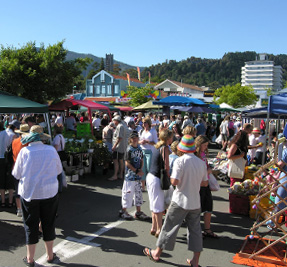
[142, 51, 287, 89]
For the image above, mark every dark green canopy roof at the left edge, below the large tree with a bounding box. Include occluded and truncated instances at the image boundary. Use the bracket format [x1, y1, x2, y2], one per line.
[0, 91, 49, 113]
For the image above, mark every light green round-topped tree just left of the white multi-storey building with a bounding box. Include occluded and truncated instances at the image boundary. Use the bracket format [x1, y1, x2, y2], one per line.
[214, 83, 257, 108]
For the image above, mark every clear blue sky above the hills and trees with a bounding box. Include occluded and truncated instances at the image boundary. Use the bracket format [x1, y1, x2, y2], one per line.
[0, 0, 287, 66]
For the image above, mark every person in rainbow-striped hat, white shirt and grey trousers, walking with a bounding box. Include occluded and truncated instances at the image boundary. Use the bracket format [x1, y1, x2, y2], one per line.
[143, 135, 208, 267]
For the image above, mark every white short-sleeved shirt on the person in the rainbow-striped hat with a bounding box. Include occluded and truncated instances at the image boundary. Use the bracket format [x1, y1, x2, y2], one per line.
[171, 153, 208, 210]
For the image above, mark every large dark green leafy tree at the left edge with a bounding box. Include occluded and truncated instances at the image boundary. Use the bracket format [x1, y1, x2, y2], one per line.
[0, 42, 90, 103]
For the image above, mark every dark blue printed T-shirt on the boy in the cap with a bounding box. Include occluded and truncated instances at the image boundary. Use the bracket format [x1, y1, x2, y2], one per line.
[125, 145, 143, 181]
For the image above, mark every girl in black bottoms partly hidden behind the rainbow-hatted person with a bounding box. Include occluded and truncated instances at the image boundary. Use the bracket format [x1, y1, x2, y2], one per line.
[195, 135, 218, 238]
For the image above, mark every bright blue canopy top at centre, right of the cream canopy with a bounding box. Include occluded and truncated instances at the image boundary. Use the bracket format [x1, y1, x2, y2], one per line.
[153, 96, 207, 106]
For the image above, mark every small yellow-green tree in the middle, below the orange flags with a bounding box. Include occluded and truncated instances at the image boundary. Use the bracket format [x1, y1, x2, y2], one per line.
[127, 84, 154, 107]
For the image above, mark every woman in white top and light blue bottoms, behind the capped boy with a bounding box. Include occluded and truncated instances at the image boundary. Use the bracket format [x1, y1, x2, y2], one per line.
[139, 117, 158, 190]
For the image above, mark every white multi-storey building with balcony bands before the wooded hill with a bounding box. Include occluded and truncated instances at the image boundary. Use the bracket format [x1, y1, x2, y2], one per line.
[241, 54, 282, 95]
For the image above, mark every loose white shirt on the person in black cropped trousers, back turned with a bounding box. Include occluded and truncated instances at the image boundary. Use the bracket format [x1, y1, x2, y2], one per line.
[12, 141, 63, 202]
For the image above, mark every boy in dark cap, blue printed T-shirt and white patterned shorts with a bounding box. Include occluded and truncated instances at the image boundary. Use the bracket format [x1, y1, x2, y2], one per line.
[119, 131, 149, 220]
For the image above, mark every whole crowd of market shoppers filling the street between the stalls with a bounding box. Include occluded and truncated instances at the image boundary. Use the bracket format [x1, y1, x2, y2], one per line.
[0, 109, 286, 266]
